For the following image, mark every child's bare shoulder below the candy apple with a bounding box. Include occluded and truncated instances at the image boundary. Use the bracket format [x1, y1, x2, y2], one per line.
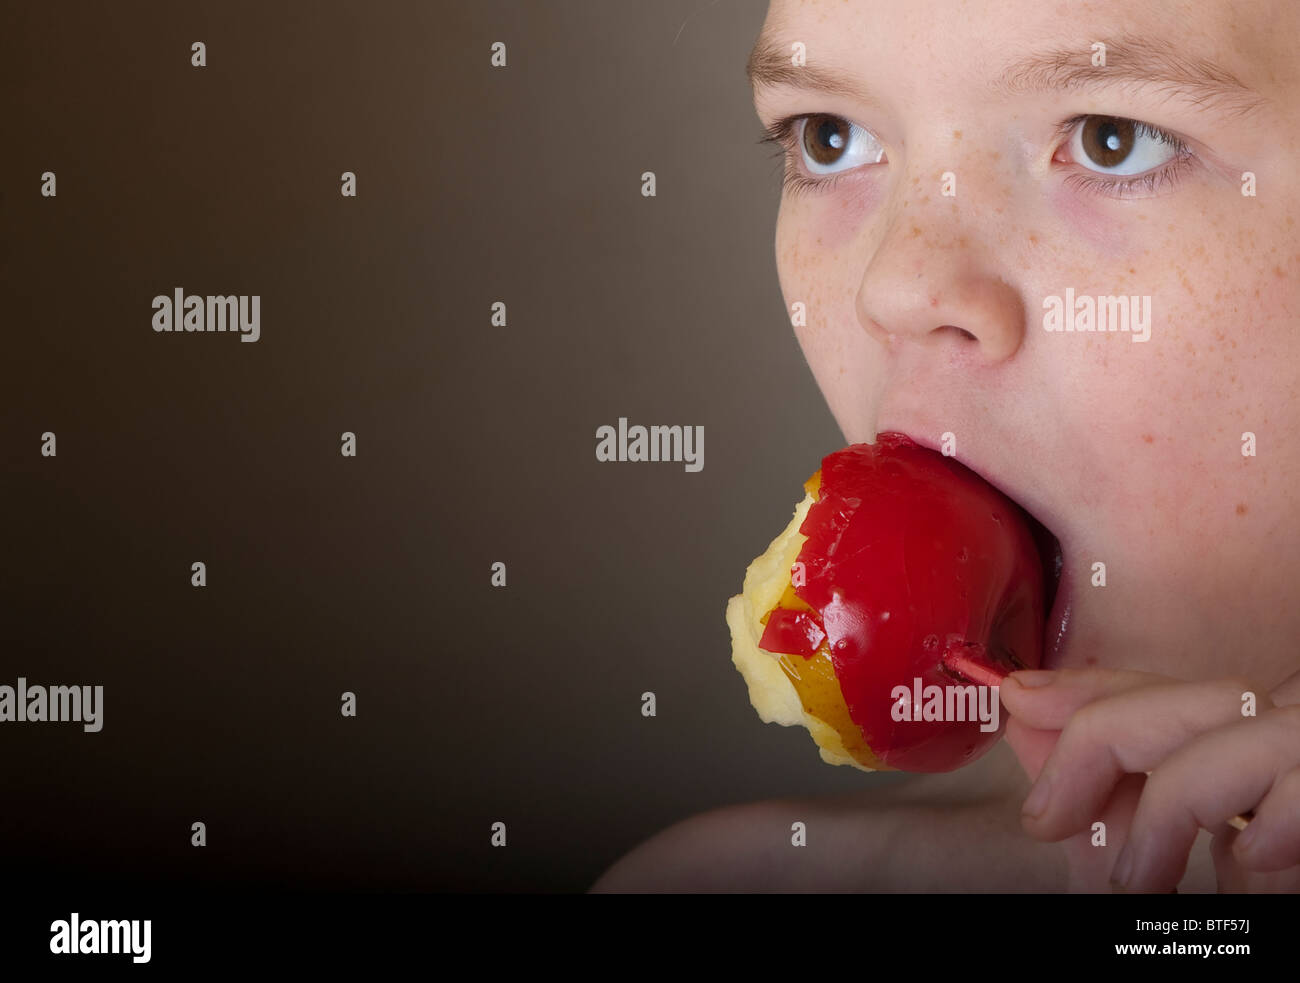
[592, 744, 1066, 893]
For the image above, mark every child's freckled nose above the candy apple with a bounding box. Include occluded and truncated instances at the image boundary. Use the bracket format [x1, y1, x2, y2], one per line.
[857, 198, 1026, 365]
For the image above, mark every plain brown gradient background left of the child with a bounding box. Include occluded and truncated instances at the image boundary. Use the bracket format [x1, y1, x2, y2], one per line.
[0, 0, 889, 891]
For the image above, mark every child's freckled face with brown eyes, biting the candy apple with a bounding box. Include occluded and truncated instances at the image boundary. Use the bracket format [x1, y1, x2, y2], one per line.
[755, 0, 1300, 679]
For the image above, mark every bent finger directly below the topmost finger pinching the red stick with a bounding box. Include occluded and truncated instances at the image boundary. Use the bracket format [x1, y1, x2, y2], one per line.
[1022, 679, 1271, 840]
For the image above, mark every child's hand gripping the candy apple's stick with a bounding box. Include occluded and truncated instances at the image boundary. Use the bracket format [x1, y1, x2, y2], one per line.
[1001, 668, 1300, 892]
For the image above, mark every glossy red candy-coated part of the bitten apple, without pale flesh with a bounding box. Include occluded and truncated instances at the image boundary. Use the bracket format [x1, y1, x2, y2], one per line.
[733, 433, 1044, 772]
